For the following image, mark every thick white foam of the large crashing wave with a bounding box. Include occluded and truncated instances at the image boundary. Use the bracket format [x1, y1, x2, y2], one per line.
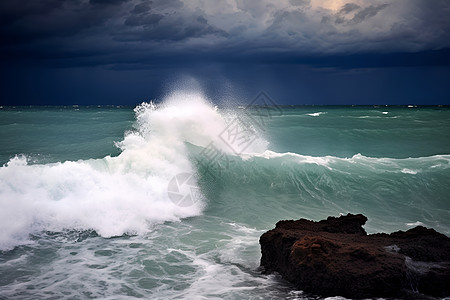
[0, 93, 267, 250]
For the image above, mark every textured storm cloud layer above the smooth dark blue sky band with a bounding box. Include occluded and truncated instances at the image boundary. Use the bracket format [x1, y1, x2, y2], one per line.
[0, 0, 450, 69]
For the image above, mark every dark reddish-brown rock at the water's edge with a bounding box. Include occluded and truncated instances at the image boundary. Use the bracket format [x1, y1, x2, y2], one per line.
[259, 214, 450, 299]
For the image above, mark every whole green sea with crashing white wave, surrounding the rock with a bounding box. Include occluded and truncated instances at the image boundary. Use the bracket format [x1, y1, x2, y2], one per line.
[0, 93, 450, 299]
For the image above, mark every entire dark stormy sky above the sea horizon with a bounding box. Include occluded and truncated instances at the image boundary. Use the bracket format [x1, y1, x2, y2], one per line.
[0, 0, 450, 105]
